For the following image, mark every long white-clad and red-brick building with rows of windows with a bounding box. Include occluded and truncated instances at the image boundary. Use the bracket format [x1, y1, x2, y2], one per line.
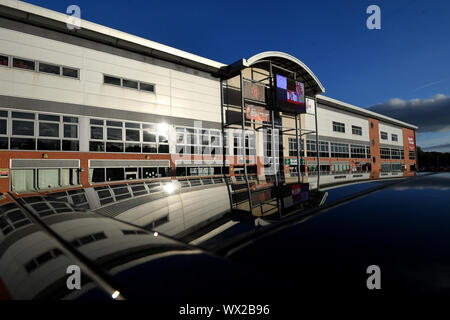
[0, 0, 416, 192]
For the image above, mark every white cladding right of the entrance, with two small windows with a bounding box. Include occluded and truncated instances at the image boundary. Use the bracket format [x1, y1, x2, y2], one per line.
[305, 103, 370, 142]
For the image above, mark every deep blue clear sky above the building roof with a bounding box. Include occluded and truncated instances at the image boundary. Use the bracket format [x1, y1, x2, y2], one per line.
[22, 0, 450, 150]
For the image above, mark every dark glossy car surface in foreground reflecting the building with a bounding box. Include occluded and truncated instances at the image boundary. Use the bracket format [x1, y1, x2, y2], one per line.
[0, 173, 450, 301]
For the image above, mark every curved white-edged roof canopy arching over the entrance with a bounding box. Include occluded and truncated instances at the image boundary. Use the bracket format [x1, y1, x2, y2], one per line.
[226, 51, 325, 96]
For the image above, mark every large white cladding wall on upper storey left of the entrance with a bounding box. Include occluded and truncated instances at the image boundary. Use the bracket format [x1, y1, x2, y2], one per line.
[0, 28, 221, 122]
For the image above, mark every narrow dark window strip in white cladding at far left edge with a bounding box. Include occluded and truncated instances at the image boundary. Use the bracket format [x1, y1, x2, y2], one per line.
[0, 54, 80, 79]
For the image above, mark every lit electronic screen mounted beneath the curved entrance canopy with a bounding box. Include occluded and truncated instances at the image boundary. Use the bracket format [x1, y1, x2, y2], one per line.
[275, 74, 306, 113]
